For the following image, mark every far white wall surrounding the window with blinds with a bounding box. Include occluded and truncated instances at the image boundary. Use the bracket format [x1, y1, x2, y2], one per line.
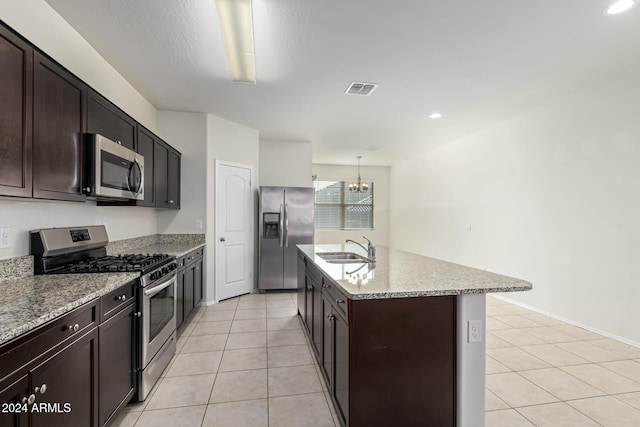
[312, 164, 390, 246]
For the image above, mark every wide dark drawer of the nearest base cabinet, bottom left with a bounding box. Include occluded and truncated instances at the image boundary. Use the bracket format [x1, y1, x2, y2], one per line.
[0, 299, 98, 381]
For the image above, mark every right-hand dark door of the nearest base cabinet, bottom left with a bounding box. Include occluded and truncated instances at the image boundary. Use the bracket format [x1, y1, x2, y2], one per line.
[31, 328, 98, 427]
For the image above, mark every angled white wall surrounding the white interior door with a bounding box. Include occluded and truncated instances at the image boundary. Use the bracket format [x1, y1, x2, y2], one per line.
[205, 115, 260, 303]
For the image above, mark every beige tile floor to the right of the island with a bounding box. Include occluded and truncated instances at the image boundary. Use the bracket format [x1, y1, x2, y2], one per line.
[485, 296, 640, 427]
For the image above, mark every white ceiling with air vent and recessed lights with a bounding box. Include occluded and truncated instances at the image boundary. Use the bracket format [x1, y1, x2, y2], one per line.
[47, 0, 640, 165]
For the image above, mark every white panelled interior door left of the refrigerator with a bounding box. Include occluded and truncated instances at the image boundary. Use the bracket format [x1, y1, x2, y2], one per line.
[215, 160, 254, 301]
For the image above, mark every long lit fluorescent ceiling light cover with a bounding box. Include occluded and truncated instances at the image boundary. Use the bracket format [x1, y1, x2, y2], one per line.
[216, 0, 256, 84]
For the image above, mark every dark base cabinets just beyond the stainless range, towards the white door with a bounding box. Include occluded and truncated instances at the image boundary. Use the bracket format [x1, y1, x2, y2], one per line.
[176, 248, 204, 333]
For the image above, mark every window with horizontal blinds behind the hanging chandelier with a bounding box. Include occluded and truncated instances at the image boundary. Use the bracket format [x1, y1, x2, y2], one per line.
[314, 181, 373, 229]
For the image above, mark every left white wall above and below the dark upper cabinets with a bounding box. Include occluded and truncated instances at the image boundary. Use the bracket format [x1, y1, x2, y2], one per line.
[0, 0, 156, 259]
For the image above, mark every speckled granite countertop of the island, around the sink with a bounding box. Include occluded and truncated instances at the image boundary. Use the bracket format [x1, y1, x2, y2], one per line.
[298, 244, 532, 300]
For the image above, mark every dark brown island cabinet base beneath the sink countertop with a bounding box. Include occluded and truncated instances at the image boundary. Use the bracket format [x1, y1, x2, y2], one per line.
[298, 257, 456, 427]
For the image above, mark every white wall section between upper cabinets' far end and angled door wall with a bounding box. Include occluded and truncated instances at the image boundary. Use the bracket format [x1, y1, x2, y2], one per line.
[157, 111, 207, 234]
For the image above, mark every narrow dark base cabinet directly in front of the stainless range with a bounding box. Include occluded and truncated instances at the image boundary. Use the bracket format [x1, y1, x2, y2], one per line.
[98, 281, 137, 427]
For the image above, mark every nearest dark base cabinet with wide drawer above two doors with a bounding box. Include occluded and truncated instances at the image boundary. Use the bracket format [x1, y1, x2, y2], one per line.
[0, 300, 99, 427]
